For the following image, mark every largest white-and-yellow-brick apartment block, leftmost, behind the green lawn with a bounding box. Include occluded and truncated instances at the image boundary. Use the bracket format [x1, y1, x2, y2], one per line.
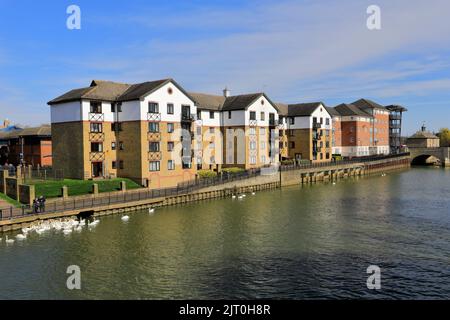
[48, 79, 197, 188]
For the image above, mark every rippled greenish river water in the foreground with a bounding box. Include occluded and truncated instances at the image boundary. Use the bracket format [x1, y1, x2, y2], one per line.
[0, 168, 450, 299]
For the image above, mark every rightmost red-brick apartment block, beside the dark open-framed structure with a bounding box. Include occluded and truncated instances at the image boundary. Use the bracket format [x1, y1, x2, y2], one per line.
[351, 99, 390, 155]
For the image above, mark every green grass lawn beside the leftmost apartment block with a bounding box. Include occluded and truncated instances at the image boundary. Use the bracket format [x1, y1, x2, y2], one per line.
[32, 178, 141, 198]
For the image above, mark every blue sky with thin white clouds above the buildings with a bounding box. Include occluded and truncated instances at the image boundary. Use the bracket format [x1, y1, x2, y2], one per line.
[0, 0, 450, 134]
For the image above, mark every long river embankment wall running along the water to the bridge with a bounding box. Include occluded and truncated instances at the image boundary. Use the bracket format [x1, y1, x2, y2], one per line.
[0, 156, 410, 232]
